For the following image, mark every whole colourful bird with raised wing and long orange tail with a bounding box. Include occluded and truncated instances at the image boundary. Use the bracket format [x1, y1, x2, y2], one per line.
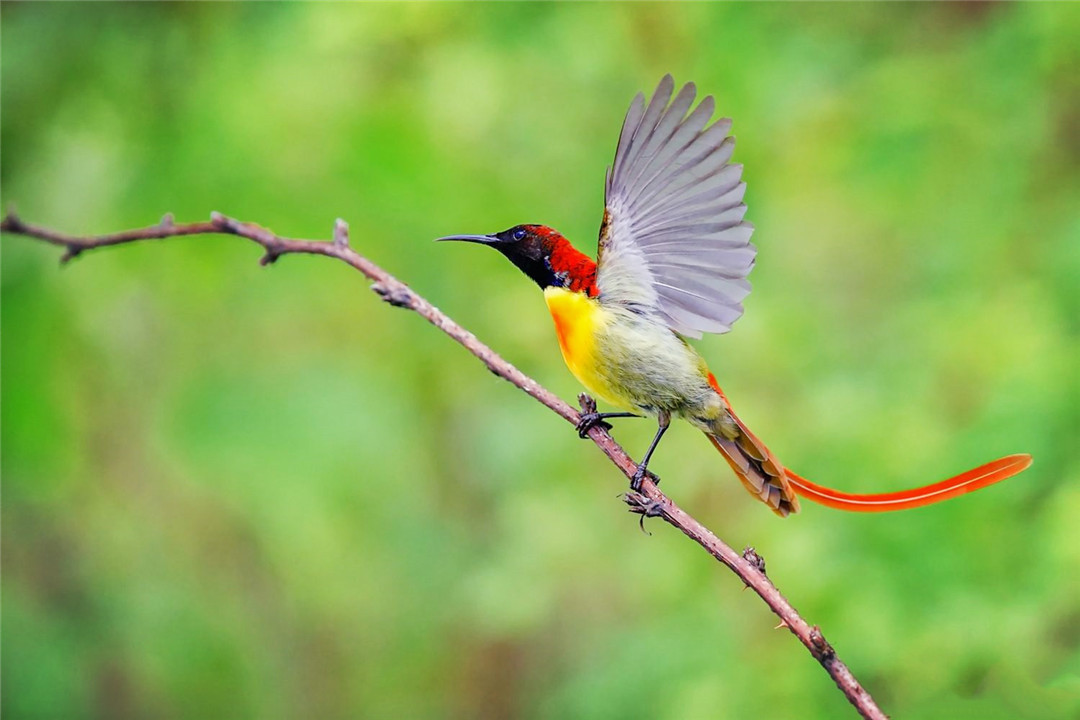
[436, 74, 1031, 517]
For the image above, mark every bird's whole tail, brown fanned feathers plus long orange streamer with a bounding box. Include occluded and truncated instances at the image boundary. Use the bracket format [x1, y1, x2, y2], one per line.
[705, 372, 1031, 516]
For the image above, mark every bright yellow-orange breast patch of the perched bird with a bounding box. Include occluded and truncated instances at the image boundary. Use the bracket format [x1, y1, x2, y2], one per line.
[543, 287, 625, 407]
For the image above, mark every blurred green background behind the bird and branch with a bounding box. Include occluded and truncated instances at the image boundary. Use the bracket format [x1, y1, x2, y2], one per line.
[0, 3, 1080, 720]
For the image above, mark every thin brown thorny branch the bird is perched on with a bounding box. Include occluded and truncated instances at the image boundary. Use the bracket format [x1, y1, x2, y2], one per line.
[0, 213, 886, 720]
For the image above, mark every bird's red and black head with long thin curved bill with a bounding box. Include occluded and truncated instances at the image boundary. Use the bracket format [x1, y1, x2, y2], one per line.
[438, 225, 596, 297]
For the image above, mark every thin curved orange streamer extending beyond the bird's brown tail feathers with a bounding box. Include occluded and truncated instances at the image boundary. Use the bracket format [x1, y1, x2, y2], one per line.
[784, 454, 1031, 513]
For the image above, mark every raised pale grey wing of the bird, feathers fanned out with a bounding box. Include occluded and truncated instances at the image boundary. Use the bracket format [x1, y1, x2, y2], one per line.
[596, 74, 757, 338]
